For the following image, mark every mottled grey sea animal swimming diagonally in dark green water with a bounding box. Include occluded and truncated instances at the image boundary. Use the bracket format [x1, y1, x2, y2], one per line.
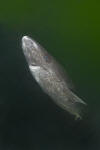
[22, 36, 86, 118]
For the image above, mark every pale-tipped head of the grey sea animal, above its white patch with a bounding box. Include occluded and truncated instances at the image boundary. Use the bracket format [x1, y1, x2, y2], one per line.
[22, 36, 51, 69]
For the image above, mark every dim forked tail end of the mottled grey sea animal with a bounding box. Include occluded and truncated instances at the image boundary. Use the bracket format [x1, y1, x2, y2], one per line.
[56, 90, 87, 120]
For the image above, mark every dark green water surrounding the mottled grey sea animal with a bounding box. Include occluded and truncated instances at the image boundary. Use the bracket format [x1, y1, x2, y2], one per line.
[0, 0, 100, 150]
